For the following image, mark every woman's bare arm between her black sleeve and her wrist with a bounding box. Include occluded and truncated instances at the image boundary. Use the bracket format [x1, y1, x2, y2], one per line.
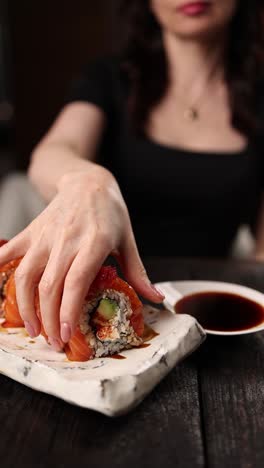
[28, 102, 105, 202]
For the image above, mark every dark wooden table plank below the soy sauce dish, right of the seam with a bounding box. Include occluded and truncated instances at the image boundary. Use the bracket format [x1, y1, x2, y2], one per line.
[196, 333, 264, 468]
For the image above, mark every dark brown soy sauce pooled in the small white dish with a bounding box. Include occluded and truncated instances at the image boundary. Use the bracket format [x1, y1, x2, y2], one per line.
[175, 291, 264, 332]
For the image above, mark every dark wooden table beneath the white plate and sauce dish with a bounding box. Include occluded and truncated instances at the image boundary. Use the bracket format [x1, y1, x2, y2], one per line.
[0, 259, 264, 468]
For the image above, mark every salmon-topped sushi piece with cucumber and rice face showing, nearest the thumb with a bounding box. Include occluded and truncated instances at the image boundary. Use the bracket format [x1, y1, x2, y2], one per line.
[65, 267, 144, 361]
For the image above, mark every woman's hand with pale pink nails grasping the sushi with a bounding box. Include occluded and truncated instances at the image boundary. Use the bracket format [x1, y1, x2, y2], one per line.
[0, 165, 163, 350]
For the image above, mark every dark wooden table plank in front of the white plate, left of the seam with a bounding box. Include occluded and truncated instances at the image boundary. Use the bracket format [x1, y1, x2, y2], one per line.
[0, 360, 204, 468]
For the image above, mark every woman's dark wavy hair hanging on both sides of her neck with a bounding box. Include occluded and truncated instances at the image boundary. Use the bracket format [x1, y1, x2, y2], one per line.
[119, 0, 264, 138]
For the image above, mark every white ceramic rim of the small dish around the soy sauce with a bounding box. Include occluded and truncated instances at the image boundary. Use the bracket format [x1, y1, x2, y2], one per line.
[156, 281, 264, 336]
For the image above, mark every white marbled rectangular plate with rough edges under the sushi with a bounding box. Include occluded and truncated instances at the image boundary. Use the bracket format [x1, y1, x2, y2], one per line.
[0, 306, 205, 416]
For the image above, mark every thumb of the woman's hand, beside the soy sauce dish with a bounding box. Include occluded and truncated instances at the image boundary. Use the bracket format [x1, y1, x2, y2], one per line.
[116, 229, 164, 304]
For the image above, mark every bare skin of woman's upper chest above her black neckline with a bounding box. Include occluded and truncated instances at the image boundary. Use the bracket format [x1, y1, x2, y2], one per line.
[146, 88, 247, 152]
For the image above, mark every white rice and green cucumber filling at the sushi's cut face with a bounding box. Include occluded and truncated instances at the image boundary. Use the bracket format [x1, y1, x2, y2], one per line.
[80, 289, 142, 357]
